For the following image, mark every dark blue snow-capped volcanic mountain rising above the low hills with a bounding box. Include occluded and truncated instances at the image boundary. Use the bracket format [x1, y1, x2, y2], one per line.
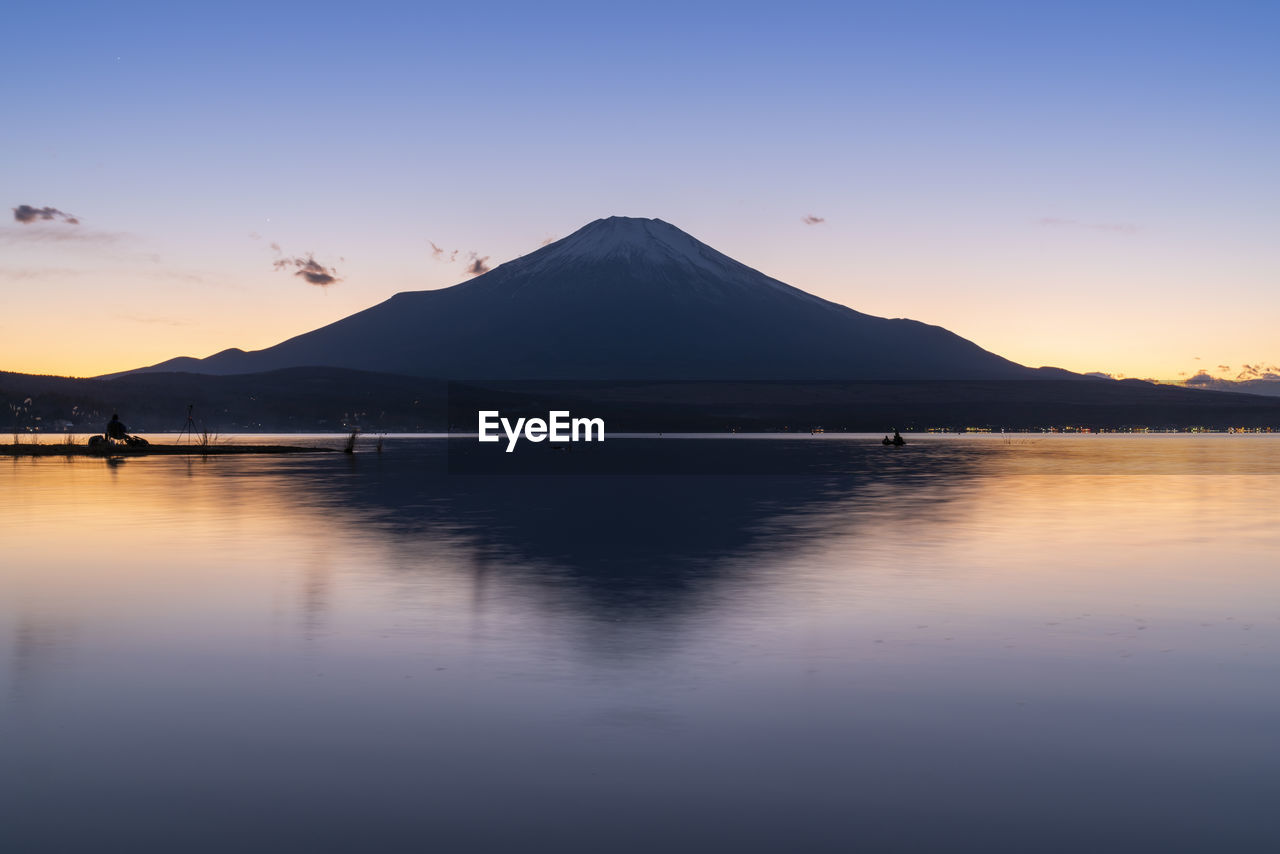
[122, 216, 1049, 380]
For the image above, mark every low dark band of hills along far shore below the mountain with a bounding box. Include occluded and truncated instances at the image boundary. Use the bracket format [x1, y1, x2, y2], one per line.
[0, 367, 1280, 443]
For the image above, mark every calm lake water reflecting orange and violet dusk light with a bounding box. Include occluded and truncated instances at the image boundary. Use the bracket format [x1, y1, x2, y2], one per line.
[0, 435, 1280, 853]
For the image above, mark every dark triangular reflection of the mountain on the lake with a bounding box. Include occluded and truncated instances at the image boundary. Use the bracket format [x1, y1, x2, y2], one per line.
[232, 443, 980, 632]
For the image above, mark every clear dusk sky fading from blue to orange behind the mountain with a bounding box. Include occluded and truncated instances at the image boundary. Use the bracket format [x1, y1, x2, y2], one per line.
[0, 0, 1280, 379]
